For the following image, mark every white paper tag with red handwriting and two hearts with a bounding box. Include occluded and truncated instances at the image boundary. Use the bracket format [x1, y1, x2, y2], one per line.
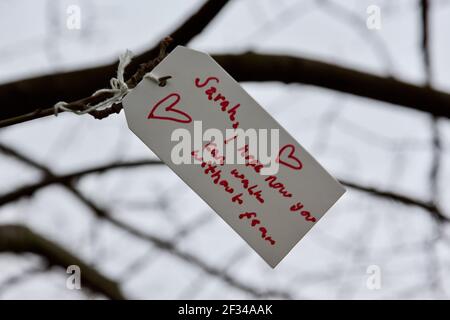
[123, 46, 345, 267]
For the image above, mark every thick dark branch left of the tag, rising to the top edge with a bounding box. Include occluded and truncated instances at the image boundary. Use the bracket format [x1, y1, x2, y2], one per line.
[0, 0, 229, 127]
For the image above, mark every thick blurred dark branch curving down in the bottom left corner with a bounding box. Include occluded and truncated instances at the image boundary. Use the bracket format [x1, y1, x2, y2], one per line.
[0, 225, 125, 300]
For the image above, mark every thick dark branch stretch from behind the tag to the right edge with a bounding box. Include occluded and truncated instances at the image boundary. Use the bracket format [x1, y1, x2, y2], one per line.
[214, 53, 450, 118]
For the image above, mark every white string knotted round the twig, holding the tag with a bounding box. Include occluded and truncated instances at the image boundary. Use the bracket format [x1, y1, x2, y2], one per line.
[54, 50, 133, 116]
